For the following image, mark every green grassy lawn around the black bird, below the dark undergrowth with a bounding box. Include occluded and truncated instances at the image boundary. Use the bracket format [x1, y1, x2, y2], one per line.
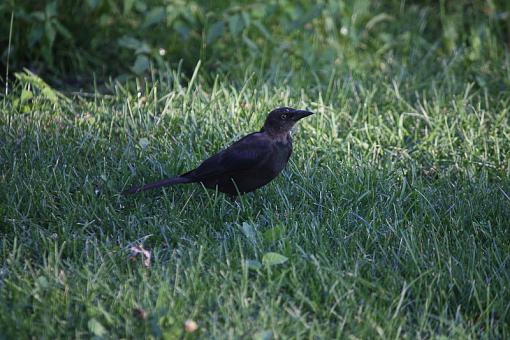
[0, 1, 510, 339]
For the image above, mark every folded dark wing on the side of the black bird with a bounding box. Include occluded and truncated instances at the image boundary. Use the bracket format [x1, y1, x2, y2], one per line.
[182, 134, 270, 181]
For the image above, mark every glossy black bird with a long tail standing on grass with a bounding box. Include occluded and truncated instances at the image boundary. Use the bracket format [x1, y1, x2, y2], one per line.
[122, 107, 313, 196]
